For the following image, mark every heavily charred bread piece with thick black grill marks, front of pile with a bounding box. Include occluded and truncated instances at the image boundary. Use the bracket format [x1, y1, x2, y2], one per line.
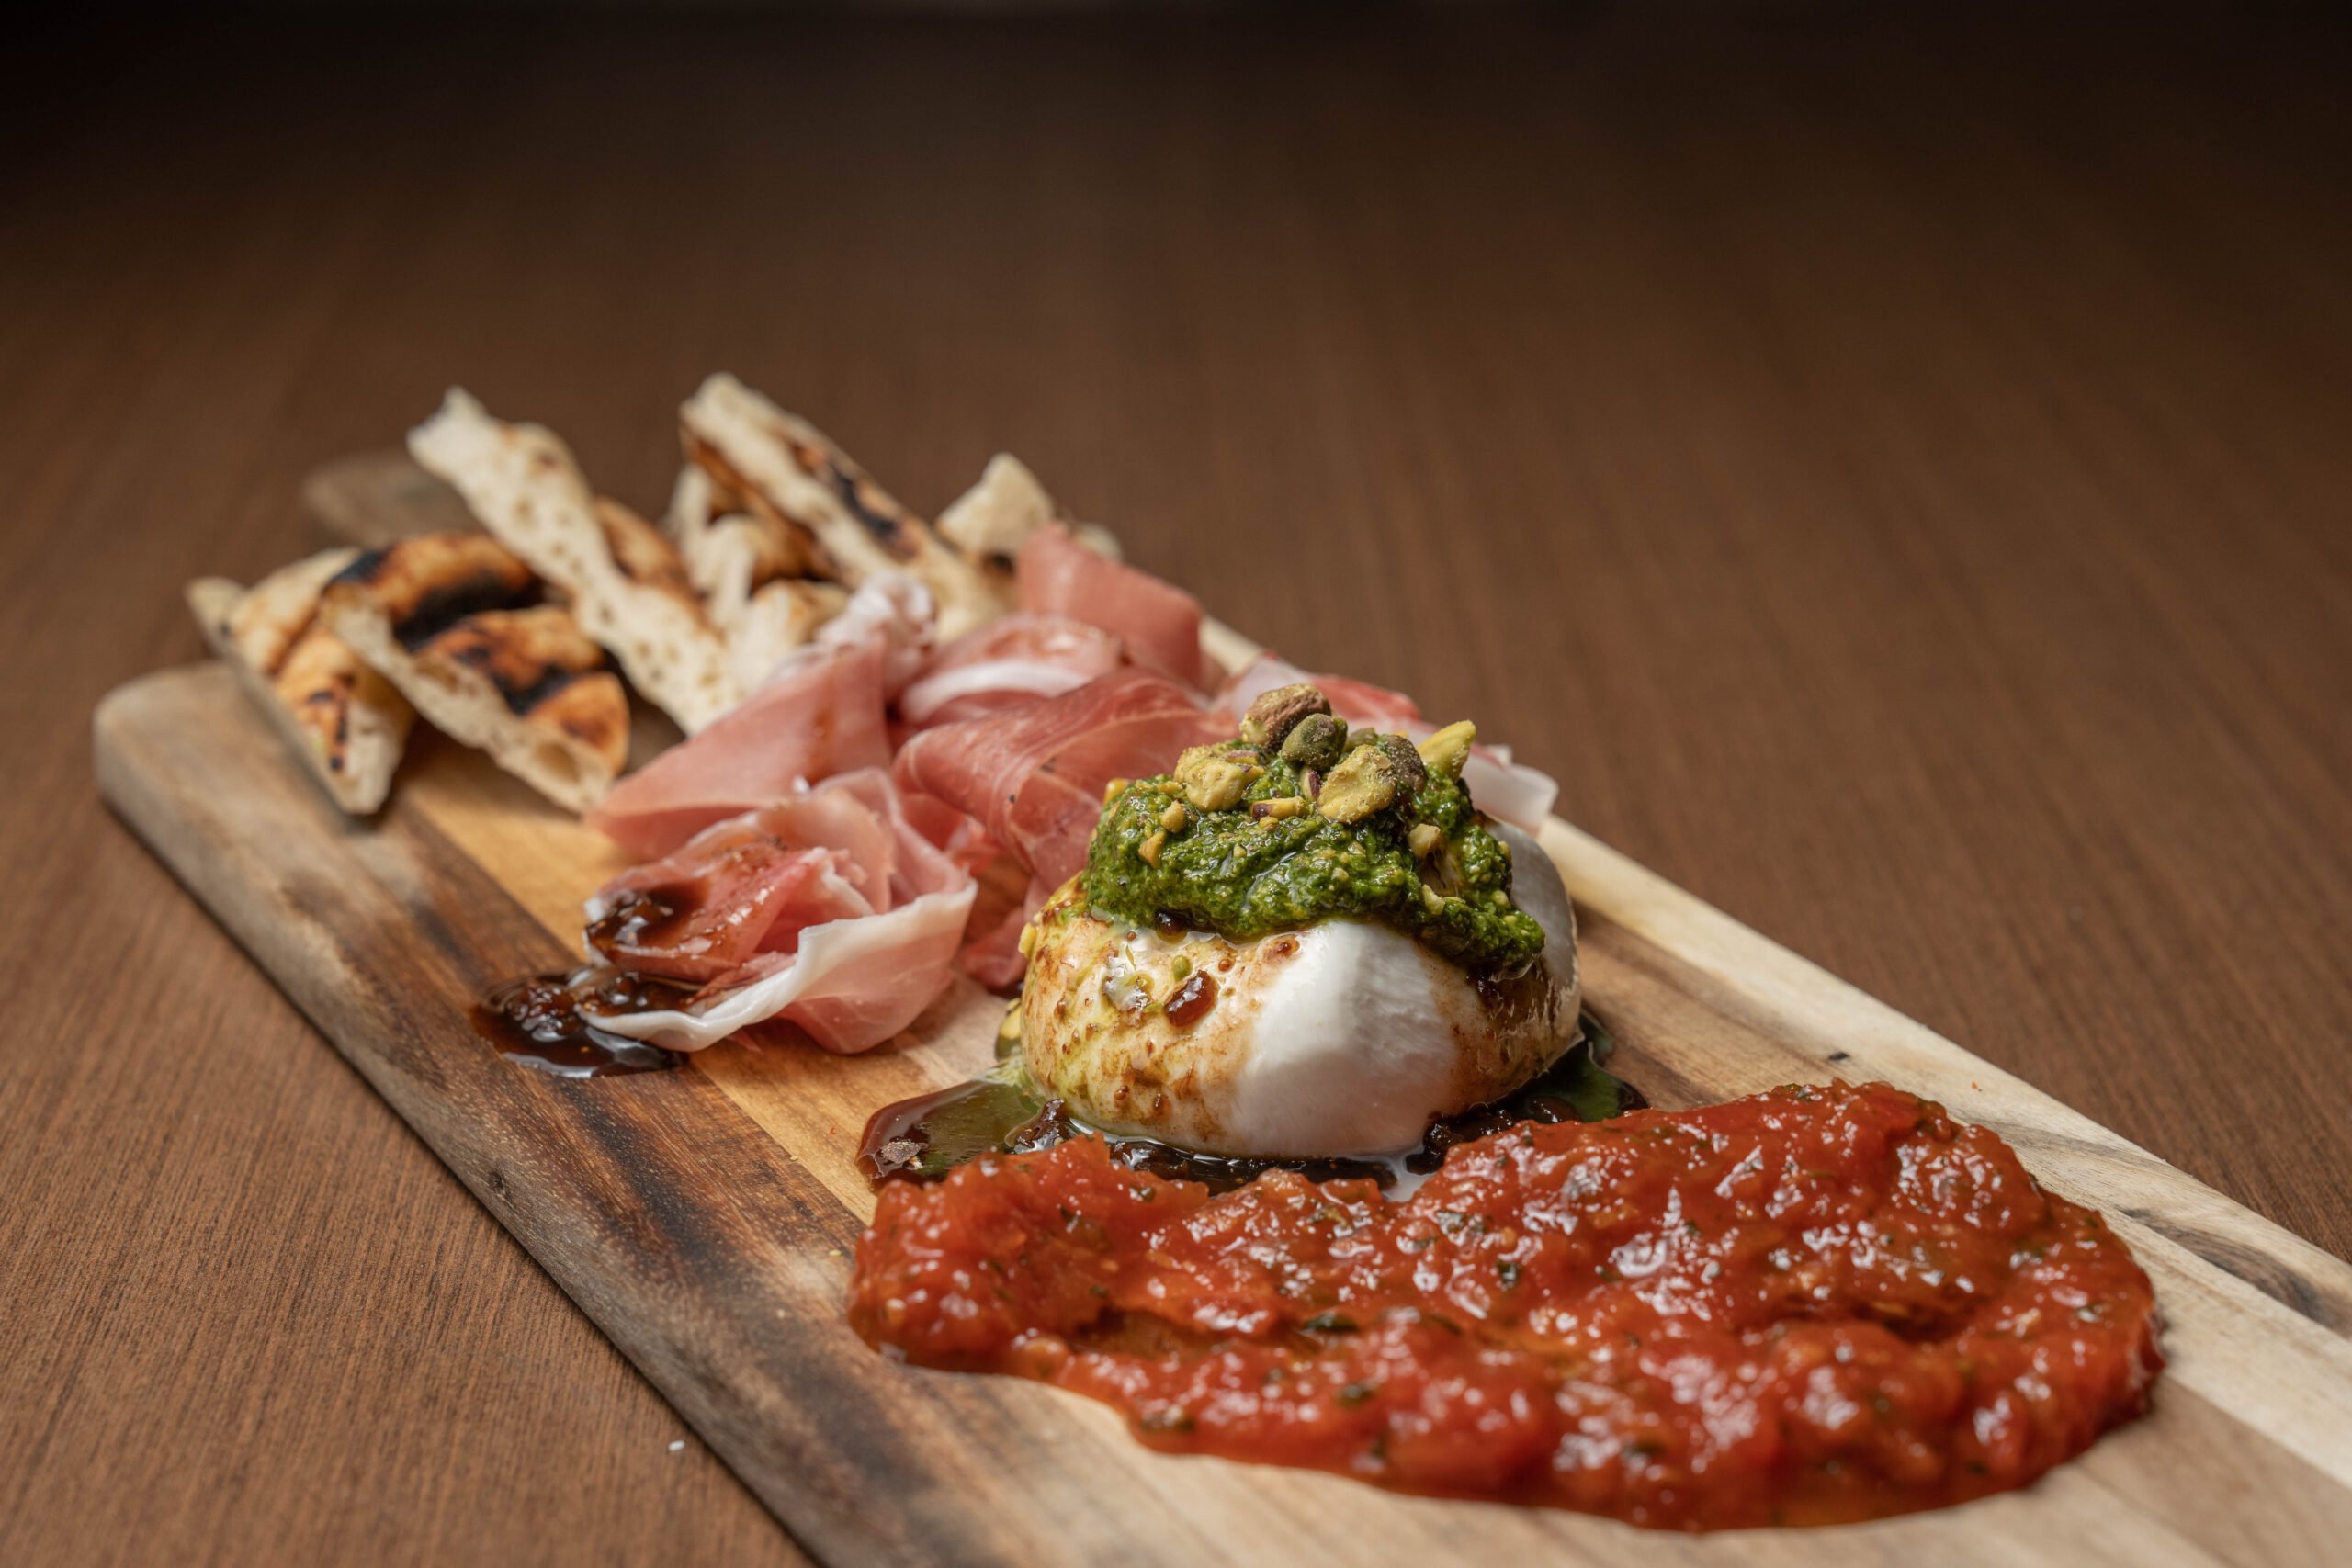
[320, 534, 628, 811]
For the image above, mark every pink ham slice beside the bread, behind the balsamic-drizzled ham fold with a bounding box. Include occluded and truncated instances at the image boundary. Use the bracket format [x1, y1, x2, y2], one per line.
[588, 576, 933, 861]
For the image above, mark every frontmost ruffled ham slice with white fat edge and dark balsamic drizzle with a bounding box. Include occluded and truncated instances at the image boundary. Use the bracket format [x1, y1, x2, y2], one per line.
[585, 769, 976, 1054]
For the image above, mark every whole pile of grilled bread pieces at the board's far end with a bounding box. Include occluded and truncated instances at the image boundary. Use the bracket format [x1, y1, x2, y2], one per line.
[202, 388, 1114, 813]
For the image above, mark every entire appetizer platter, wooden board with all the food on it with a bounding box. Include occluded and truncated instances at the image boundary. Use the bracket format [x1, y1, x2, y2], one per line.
[96, 376, 2352, 1563]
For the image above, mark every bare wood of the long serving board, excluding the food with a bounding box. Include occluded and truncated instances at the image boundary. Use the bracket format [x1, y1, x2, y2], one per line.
[96, 484, 2352, 1568]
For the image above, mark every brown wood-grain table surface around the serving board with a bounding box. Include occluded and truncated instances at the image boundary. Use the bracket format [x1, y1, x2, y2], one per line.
[0, 9, 2352, 1563]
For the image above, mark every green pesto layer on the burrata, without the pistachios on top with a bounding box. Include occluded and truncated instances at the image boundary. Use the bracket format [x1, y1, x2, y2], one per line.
[1084, 740, 1543, 968]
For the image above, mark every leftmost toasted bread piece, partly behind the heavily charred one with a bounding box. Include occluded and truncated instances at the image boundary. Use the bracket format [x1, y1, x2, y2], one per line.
[188, 550, 416, 816]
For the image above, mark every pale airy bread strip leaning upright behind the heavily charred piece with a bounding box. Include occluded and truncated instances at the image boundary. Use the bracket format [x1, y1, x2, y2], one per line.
[409, 390, 743, 733]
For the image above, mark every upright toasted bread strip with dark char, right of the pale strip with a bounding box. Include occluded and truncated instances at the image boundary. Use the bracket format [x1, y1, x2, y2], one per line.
[677, 374, 1004, 639]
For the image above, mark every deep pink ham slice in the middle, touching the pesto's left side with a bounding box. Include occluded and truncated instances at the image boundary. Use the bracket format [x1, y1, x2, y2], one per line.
[891, 665, 1232, 886]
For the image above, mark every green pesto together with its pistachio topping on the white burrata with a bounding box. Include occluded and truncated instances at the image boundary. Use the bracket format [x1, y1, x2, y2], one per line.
[1082, 686, 1545, 968]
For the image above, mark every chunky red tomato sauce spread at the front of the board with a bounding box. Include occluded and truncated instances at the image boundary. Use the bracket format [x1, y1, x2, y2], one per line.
[849, 1084, 2164, 1530]
